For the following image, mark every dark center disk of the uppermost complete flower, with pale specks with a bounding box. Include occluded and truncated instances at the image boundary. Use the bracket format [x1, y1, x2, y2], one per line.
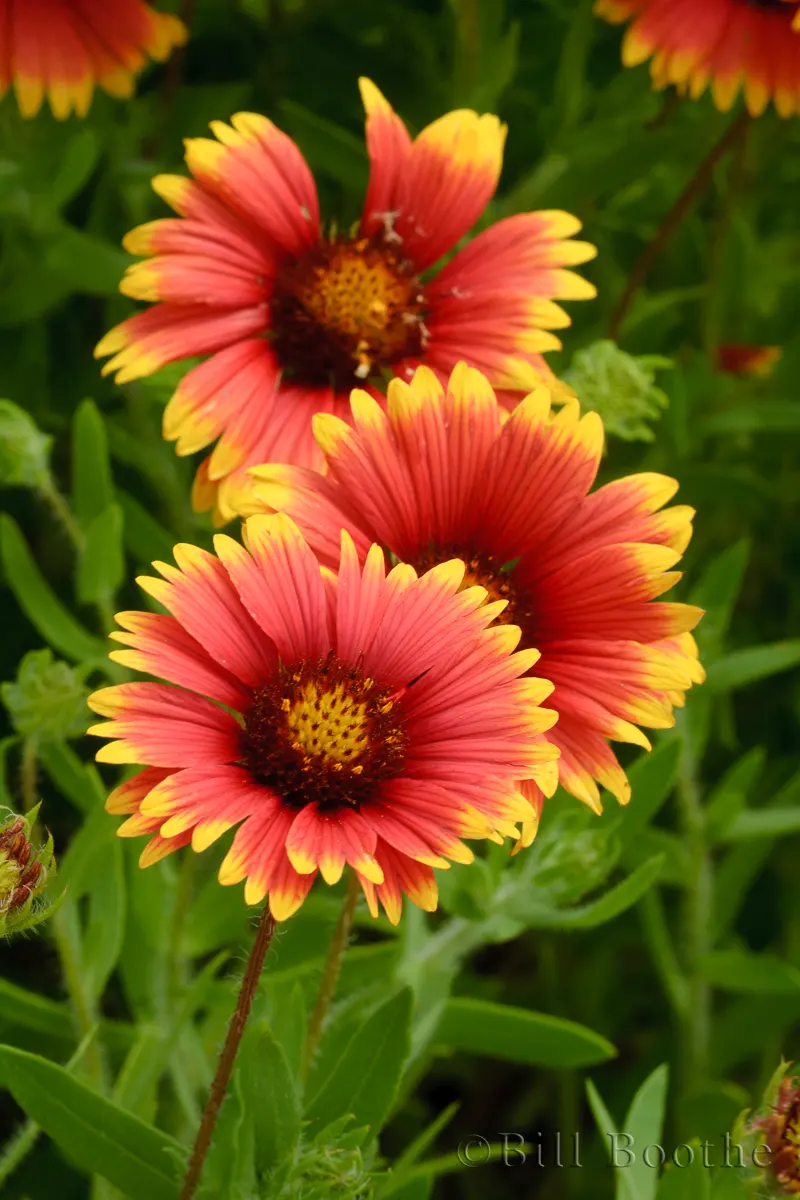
[272, 238, 425, 390]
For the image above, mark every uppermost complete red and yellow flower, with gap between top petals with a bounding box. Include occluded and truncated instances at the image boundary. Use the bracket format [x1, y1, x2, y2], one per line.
[96, 79, 595, 520]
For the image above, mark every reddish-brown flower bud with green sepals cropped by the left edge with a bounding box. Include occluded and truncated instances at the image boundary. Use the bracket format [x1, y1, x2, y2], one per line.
[0, 806, 58, 937]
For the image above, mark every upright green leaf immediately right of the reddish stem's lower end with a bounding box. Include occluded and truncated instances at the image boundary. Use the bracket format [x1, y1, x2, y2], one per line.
[240, 1022, 301, 1171]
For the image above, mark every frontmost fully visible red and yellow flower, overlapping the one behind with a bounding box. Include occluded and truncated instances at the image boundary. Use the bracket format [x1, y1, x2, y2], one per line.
[89, 516, 558, 922]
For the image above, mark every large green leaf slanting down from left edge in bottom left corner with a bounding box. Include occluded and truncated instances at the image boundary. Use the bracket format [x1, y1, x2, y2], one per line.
[0, 1046, 185, 1200]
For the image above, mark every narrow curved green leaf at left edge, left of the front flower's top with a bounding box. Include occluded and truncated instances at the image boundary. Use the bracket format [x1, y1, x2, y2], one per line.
[0, 512, 106, 662]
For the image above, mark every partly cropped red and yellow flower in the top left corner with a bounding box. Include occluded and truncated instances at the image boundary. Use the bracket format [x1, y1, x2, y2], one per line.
[0, 0, 186, 120]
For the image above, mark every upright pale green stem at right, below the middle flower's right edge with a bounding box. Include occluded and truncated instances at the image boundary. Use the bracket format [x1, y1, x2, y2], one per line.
[678, 746, 714, 1091]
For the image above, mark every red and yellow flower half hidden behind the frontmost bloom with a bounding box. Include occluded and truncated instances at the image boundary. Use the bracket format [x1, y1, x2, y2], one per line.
[236, 364, 703, 840]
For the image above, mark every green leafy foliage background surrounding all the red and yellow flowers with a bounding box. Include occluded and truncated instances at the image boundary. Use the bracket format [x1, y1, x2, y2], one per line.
[0, 0, 800, 1200]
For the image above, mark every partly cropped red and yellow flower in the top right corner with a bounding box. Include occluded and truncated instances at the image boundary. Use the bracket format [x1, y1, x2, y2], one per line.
[595, 0, 800, 116]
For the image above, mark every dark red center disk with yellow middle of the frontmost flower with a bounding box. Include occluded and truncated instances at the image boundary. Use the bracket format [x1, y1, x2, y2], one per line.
[241, 654, 408, 811]
